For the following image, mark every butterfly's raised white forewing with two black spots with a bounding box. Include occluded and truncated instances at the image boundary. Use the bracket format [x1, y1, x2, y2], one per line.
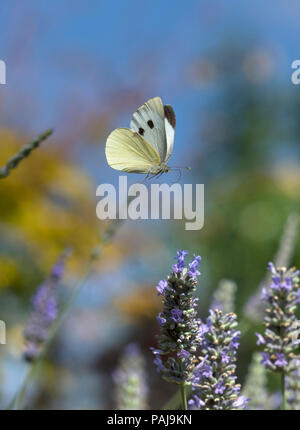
[130, 97, 167, 161]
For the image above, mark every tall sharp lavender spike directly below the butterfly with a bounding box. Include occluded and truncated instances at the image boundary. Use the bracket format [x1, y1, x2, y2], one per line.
[152, 250, 201, 384]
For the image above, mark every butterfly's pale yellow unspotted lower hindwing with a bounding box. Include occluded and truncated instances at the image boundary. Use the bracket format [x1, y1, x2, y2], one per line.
[105, 128, 161, 173]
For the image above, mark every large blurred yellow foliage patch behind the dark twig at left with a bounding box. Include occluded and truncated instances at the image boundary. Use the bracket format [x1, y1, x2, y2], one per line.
[0, 130, 106, 288]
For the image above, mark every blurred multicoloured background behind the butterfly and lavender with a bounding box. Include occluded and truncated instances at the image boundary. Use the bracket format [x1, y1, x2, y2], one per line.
[0, 0, 300, 409]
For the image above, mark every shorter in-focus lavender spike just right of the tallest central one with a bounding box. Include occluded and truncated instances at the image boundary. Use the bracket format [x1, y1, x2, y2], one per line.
[189, 309, 249, 410]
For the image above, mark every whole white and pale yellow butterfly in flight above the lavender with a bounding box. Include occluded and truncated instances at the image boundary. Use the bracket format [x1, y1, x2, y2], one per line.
[105, 97, 176, 176]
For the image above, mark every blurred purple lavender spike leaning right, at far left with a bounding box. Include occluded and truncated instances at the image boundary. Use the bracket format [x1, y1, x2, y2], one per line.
[23, 252, 69, 361]
